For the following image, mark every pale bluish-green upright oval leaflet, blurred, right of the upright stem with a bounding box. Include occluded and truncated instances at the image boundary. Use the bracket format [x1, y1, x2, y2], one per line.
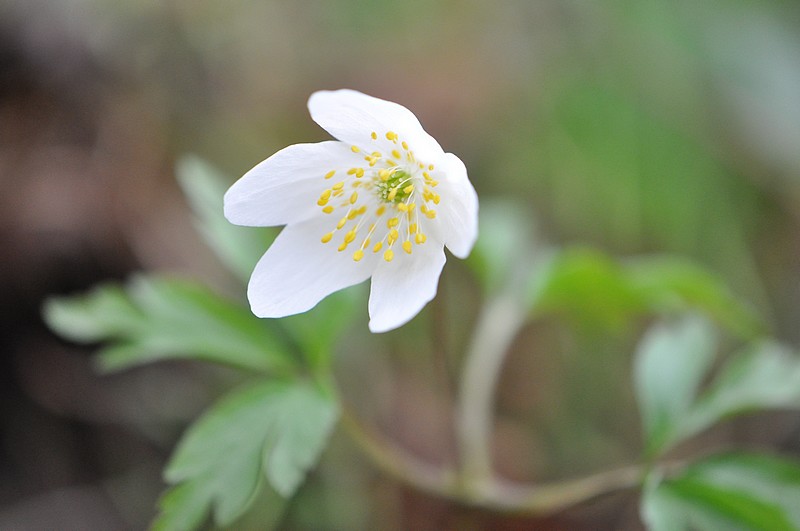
[634, 316, 716, 457]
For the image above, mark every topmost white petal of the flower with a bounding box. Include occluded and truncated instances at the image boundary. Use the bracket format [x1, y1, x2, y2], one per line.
[308, 89, 442, 160]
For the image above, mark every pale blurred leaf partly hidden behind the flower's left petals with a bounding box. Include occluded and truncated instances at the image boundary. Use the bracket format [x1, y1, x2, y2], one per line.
[176, 155, 277, 281]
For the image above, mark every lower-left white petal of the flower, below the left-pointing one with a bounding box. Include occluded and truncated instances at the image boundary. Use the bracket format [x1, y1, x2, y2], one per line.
[247, 217, 377, 317]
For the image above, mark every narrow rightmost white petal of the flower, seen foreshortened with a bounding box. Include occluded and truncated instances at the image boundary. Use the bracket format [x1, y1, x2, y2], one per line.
[437, 153, 478, 258]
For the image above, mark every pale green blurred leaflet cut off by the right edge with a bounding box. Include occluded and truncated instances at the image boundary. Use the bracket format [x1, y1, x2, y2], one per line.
[683, 342, 800, 436]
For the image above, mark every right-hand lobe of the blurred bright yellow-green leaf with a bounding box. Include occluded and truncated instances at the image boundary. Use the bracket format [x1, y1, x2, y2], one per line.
[625, 256, 764, 338]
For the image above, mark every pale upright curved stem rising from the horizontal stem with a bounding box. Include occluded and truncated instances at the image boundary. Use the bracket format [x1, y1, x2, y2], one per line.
[456, 294, 526, 496]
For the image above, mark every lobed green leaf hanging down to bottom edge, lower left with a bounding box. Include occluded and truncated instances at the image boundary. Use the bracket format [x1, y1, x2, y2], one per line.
[154, 381, 338, 531]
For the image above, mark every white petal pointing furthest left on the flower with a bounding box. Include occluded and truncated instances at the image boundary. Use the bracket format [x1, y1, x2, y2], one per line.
[224, 140, 363, 227]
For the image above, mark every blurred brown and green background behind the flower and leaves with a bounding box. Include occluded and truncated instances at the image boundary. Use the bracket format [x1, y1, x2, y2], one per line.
[0, 0, 800, 530]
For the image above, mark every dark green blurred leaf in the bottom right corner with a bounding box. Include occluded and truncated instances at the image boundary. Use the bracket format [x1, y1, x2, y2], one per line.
[641, 453, 800, 531]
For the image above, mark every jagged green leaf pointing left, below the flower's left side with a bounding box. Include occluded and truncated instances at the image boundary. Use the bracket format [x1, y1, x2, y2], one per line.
[44, 276, 294, 372]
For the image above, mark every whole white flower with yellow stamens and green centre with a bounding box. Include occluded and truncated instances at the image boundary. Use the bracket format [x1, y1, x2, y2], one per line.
[225, 90, 478, 332]
